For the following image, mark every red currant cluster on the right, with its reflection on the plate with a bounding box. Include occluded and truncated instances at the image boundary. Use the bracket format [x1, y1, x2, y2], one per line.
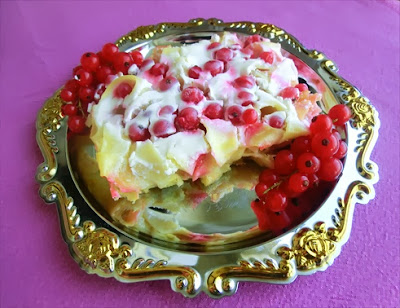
[251, 105, 351, 230]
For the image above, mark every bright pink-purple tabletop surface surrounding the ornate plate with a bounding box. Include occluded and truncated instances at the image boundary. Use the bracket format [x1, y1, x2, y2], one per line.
[0, 0, 400, 307]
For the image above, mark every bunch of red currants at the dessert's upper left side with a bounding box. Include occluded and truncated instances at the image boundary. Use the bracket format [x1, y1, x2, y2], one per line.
[60, 43, 143, 133]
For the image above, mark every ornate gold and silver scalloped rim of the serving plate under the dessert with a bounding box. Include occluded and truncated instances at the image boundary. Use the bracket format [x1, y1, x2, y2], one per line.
[36, 19, 380, 298]
